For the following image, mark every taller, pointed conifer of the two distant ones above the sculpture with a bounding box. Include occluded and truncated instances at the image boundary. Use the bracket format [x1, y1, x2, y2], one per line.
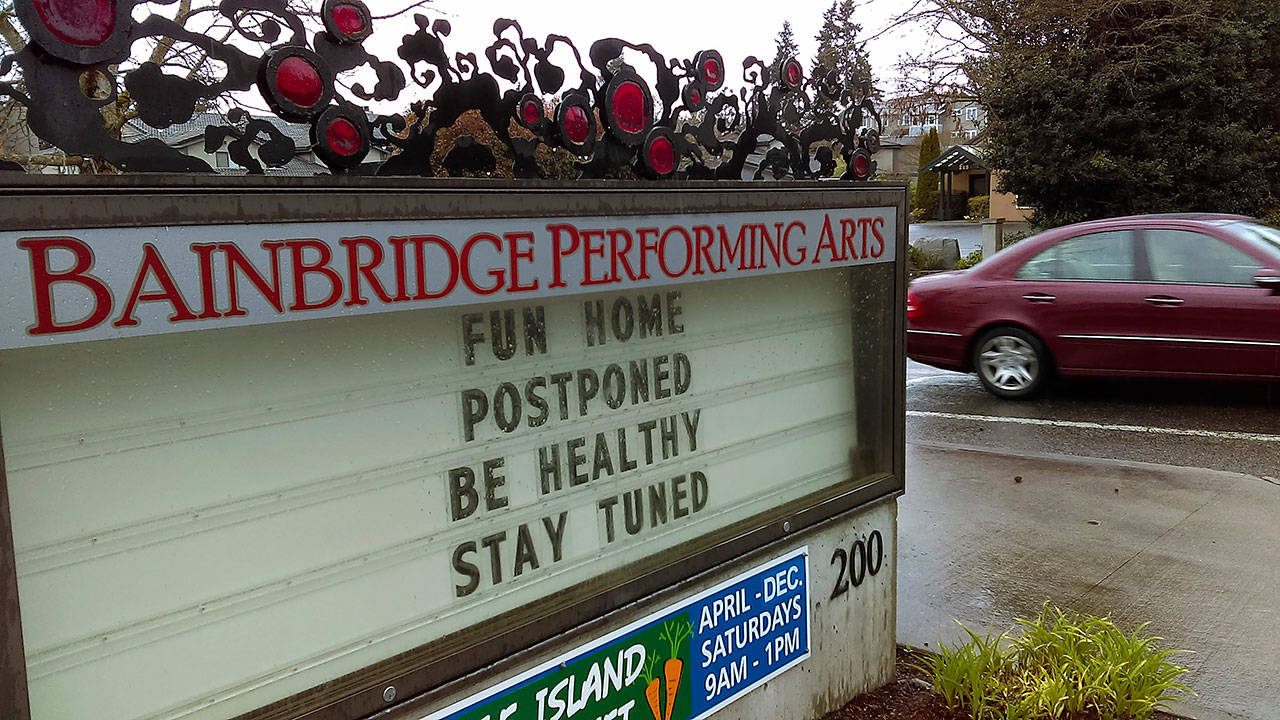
[809, 0, 873, 120]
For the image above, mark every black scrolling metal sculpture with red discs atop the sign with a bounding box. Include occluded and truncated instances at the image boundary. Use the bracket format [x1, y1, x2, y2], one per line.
[0, 0, 882, 179]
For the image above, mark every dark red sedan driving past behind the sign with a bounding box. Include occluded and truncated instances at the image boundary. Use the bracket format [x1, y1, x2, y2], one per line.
[906, 215, 1280, 398]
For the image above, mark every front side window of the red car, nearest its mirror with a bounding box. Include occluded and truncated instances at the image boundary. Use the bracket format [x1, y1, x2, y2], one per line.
[1147, 229, 1262, 284]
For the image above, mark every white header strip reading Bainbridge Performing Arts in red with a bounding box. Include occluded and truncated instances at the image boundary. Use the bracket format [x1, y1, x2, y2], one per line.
[0, 208, 897, 354]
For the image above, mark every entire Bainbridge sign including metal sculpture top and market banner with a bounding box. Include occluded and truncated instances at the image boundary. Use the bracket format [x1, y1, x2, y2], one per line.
[0, 0, 908, 720]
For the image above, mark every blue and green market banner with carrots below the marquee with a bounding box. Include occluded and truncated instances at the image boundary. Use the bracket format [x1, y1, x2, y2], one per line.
[422, 548, 809, 720]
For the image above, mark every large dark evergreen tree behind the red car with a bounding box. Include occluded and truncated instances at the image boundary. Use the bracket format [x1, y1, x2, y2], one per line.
[968, 0, 1280, 225]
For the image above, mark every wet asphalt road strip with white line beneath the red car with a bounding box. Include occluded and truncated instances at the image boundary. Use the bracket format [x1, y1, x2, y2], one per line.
[906, 363, 1280, 483]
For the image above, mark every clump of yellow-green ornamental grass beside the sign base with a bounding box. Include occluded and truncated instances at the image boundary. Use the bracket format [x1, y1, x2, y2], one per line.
[922, 603, 1190, 720]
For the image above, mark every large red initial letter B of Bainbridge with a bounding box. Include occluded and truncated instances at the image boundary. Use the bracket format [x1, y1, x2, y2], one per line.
[18, 237, 111, 334]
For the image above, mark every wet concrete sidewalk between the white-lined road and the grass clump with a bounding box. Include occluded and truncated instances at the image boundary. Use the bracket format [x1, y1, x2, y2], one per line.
[897, 445, 1280, 720]
